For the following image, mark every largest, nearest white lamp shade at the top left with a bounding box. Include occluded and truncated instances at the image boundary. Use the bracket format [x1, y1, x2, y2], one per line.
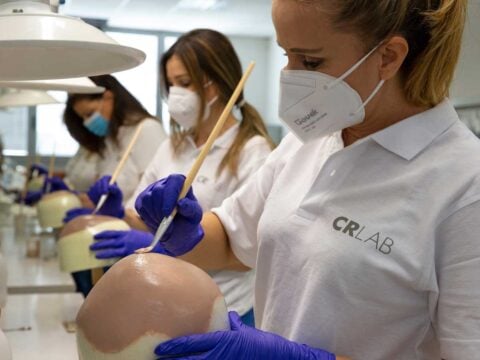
[0, 0, 145, 80]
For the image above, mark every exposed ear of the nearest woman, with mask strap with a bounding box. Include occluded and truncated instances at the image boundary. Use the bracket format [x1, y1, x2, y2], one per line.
[379, 36, 409, 80]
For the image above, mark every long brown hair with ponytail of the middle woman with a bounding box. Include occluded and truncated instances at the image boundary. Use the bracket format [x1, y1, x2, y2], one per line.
[160, 29, 274, 175]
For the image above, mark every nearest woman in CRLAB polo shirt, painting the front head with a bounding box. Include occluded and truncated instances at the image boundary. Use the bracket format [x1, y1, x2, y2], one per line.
[128, 0, 480, 360]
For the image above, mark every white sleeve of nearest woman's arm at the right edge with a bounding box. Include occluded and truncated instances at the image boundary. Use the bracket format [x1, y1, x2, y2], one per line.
[434, 201, 480, 359]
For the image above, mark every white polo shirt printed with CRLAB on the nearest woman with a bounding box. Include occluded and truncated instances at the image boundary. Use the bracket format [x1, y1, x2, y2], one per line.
[214, 101, 480, 360]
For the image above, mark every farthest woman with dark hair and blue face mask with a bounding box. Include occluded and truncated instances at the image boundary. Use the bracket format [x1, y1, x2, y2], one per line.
[64, 75, 166, 202]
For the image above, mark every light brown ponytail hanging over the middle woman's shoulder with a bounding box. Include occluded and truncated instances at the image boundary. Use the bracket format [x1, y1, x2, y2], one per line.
[217, 101, 275, 176]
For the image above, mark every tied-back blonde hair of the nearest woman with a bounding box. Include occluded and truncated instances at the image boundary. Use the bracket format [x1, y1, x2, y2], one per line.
[298, 0, 467, 106]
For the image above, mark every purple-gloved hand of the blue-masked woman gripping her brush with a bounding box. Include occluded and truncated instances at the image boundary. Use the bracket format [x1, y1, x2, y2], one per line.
[87, 176, 125, 219]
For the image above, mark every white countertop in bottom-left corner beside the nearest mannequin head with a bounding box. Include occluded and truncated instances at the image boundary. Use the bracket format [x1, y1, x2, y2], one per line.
[0, 294, 83, 360]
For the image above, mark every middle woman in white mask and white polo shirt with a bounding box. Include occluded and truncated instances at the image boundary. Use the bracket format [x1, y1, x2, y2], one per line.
[88, 30, 273, 326]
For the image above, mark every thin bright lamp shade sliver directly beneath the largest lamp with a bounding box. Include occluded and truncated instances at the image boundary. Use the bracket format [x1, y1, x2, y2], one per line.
[0, 77, 105, 94]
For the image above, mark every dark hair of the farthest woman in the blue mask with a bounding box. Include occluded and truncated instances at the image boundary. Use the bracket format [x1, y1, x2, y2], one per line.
[63, 75, 155, 155]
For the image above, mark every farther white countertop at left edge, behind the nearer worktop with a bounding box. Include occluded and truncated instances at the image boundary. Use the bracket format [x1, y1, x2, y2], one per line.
[0, 214, 75, 294]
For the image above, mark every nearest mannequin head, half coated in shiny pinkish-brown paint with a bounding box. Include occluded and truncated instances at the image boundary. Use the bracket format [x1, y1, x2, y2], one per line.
[77, 253, 229, 360]
